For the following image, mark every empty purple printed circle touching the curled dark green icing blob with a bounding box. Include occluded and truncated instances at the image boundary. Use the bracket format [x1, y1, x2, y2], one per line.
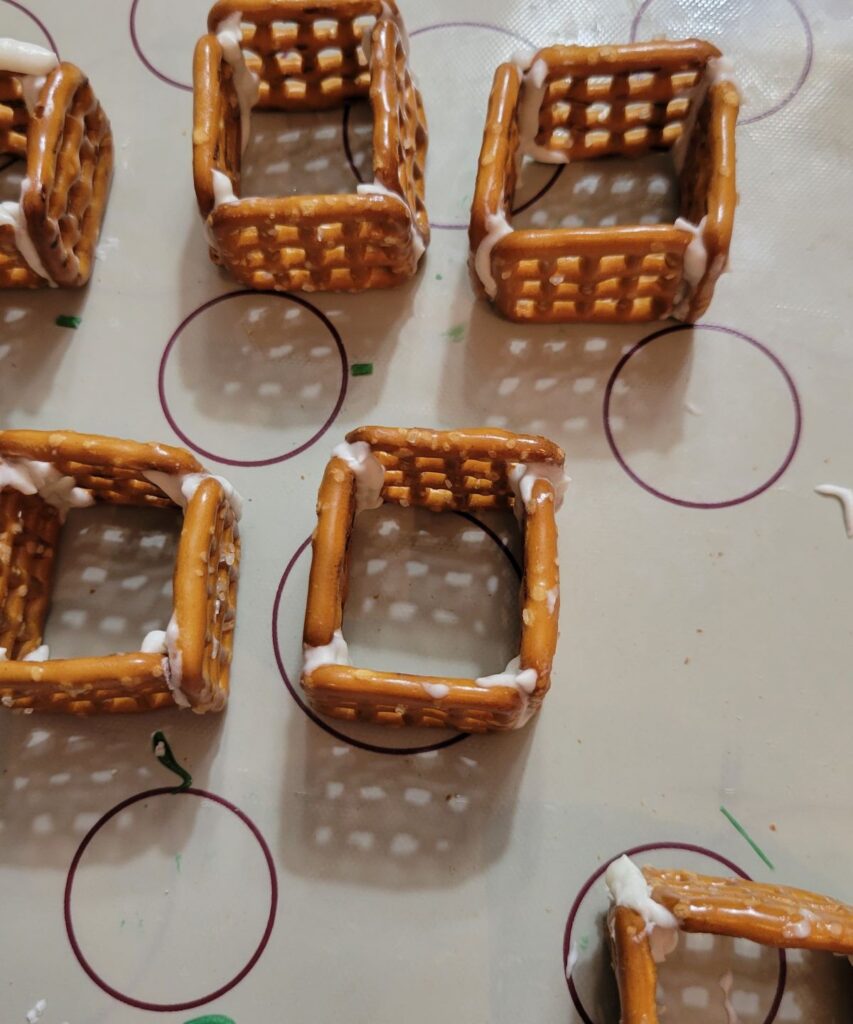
[63, 786, 279, 1013]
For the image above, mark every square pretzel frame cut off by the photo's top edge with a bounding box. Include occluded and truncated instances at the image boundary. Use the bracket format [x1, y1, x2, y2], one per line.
[193, 0, 429, 292]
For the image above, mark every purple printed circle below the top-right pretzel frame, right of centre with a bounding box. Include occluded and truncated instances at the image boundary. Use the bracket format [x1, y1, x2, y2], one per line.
[603, 324, 803, 509]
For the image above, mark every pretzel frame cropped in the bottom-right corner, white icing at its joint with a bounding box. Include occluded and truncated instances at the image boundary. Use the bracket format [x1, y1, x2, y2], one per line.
[609, 867, 853, 1024]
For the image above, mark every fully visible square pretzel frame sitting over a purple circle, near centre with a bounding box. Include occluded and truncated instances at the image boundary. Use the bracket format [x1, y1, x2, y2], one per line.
[302, 427, 564, 732]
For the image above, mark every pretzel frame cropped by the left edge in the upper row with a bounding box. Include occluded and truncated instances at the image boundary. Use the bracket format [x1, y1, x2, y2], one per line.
[0, 61, 113, 288]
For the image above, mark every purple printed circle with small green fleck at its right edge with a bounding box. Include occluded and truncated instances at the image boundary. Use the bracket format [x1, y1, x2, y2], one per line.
[157, 288, 349, 468]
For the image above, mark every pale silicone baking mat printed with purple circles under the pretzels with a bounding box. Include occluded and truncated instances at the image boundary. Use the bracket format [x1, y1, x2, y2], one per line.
[0, 0, 853, 1024]
